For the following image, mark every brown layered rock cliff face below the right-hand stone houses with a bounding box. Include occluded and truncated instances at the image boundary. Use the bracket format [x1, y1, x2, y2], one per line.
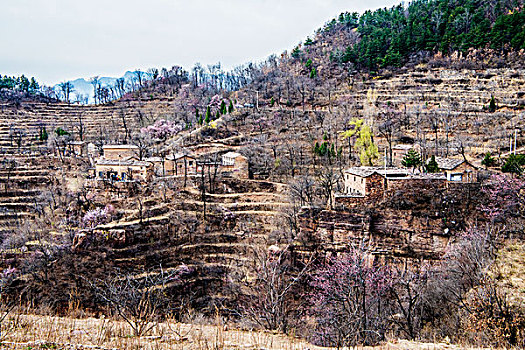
[299, 183, 482, 262]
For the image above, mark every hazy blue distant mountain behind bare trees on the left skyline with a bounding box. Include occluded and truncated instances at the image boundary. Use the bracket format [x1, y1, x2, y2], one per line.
[53, 71, 151, 103]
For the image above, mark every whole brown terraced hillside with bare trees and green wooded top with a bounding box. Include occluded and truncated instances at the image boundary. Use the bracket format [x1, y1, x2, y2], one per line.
[0, 0, 525, 348]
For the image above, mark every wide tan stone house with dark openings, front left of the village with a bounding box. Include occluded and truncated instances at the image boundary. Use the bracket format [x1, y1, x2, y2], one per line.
[95, 158, 154, 182]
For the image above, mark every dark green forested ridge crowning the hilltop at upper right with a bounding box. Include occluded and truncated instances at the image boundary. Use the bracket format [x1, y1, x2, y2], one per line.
[291, 0, 525, 75]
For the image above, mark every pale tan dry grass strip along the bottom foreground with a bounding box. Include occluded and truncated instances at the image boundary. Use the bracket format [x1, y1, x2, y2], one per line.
[0, 315, 484, 350]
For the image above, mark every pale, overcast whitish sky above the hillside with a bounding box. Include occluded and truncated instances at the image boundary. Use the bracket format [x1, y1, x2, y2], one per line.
[0, 0, 401, 85]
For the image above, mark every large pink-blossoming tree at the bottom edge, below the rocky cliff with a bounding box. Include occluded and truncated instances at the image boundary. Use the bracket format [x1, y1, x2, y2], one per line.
[311, 248, 391, 347]
